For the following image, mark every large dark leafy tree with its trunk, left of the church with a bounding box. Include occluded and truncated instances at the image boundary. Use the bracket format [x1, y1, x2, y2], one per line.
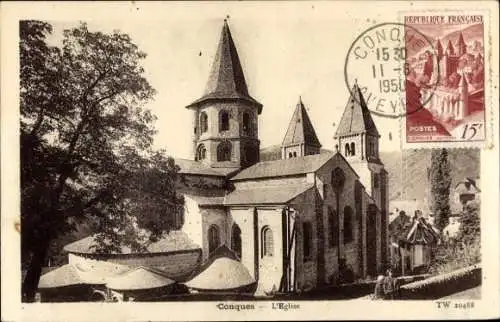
[20, 21, 183, 301]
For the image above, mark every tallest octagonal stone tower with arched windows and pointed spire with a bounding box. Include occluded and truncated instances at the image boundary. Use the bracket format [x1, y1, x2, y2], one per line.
[187, 20, 262, 170]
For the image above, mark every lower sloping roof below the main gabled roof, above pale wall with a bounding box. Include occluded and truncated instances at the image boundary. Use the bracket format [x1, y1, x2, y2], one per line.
[224, 184, 314, 206]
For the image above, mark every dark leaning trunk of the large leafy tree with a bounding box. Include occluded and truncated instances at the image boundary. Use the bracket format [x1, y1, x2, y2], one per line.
[21, 238, 49, 302]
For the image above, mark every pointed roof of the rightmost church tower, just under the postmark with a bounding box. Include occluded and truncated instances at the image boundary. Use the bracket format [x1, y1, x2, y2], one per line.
[335, 83, 380, 138]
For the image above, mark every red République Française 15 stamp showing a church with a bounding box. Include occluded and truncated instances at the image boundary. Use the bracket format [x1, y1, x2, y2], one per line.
[405, 15, 486, 143]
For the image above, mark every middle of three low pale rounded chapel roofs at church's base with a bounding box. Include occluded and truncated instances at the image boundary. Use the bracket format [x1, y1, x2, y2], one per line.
[106, 266, 175, 291]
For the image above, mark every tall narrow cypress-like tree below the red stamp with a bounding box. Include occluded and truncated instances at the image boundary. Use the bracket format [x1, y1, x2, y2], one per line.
[429, 149, 451, 232]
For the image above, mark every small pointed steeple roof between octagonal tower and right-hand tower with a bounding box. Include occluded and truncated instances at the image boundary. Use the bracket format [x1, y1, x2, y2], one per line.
[282, 98, 321, 147]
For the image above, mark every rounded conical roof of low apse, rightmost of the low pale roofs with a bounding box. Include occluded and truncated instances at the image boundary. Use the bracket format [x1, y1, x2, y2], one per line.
[185, 246, 255, 291]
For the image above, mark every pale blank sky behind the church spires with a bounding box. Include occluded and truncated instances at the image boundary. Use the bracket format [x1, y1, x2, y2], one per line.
[49, 3, 406, 158]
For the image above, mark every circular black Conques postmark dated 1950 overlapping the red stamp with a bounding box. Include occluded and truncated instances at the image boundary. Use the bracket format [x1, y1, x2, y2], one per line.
[344, 22, 439, 118]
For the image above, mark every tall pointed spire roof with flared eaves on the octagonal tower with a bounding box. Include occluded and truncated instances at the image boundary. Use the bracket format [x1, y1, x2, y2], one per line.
[188, 20, 262, 113]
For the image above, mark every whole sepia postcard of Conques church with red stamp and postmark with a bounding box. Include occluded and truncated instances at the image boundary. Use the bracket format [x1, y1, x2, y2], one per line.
[2, 1, 498, 320]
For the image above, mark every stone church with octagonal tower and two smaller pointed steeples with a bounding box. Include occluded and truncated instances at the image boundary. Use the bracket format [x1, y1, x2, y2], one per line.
[176, 21, 388, 294]
